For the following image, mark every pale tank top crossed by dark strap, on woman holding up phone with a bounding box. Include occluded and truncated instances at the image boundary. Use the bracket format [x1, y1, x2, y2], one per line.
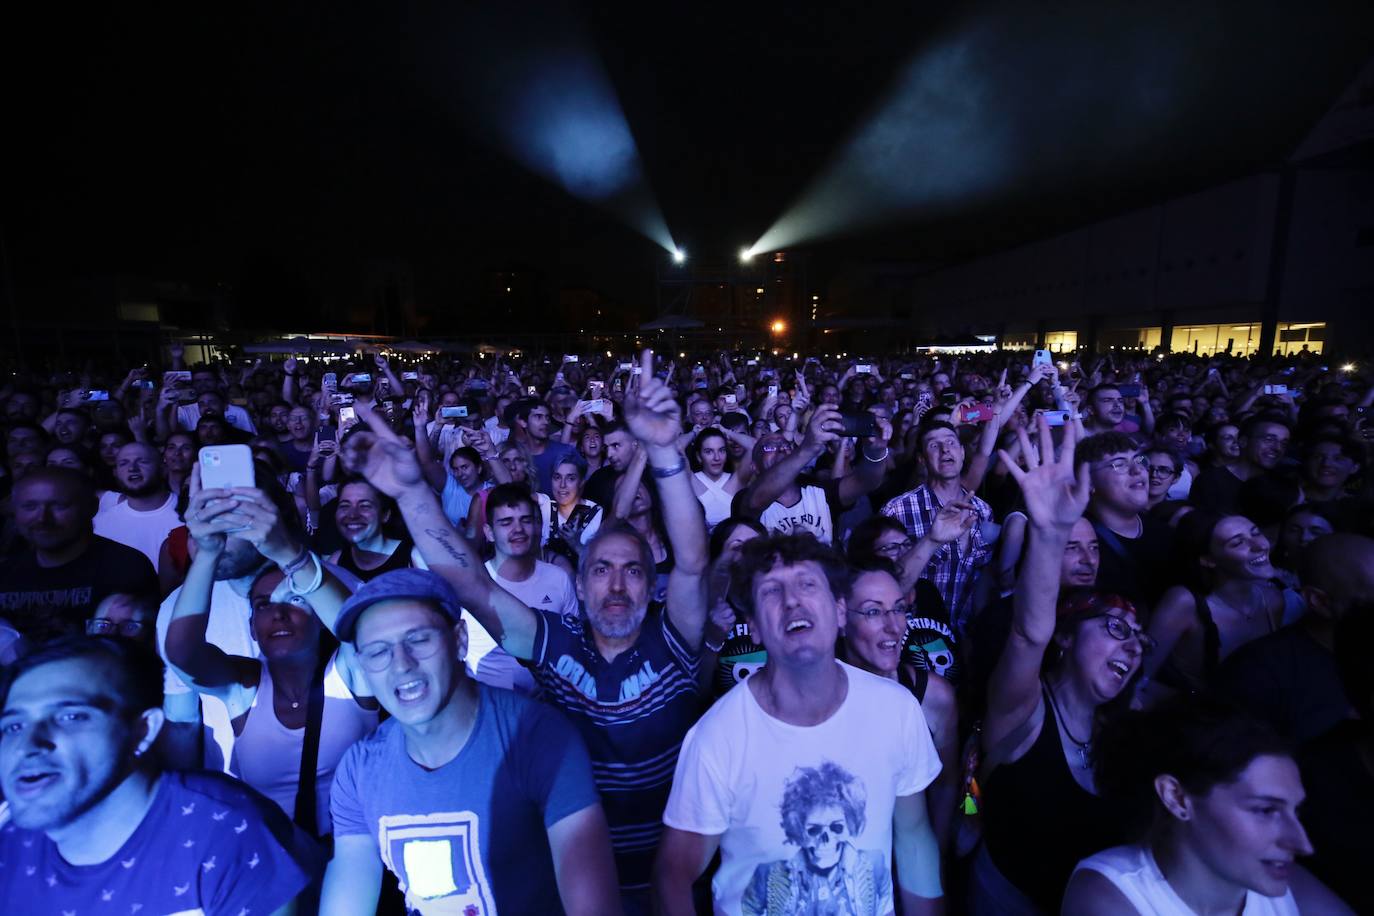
[229, 655, 376, 836]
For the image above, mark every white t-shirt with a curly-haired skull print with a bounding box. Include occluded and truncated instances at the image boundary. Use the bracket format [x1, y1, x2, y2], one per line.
[664, 661, 940, 916]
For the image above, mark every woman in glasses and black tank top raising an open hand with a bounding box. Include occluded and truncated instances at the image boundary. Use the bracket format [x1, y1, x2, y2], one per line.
[970, 417, 1149, 916]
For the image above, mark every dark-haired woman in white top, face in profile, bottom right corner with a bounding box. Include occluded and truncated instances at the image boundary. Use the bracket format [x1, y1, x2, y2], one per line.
[1062, 698, 1353, 916]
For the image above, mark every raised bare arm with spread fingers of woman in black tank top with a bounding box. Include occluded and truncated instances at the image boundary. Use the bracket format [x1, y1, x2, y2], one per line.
[982, 417, 1090, 748]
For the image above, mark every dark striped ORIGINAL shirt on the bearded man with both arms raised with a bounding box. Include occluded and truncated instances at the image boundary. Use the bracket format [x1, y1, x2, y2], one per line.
[533, 606, 702, 890]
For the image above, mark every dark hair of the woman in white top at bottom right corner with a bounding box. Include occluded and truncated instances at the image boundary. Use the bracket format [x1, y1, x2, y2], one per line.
[1096, 695, 1292, 828]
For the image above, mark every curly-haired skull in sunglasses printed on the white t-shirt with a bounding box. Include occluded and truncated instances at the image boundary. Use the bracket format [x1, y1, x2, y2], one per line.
[741, 761, 892, 916]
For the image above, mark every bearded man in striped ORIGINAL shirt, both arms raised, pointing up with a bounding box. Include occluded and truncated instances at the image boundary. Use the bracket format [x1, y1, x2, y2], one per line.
[348, 350, 706, 913]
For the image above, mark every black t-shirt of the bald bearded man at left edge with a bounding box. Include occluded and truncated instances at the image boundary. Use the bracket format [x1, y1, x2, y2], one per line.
[0, 534, 158, 643]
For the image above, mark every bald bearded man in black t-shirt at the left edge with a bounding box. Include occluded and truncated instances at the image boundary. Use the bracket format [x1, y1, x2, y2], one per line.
[0, 467, 158, 643]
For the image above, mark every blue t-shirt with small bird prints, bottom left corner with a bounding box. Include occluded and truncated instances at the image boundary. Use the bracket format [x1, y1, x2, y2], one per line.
[0, 772, 320, 916]
